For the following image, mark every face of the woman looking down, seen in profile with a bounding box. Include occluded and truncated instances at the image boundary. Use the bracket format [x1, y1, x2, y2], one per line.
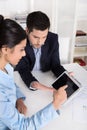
[5, 39, 26, 65]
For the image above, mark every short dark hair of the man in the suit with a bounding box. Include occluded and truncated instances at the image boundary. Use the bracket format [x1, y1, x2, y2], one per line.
[26, 11, 50, 32]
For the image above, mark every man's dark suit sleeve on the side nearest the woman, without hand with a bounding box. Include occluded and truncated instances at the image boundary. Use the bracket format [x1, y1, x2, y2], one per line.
[14, 57, 37, 88]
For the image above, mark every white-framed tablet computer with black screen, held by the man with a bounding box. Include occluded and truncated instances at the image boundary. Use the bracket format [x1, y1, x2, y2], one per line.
[52, 71, 83, 104]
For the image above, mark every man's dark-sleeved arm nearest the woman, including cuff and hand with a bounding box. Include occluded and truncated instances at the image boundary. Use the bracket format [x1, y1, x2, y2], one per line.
[15, 57, 53, 92]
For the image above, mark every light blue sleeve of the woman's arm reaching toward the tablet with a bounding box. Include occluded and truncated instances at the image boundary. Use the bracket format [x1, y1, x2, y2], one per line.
[0, 102, 58, 130]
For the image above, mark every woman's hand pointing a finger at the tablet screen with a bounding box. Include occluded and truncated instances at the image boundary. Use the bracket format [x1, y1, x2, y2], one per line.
[53, 85, 67, 110]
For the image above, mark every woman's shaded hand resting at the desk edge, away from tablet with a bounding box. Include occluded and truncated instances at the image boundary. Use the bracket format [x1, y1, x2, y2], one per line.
[16, 98, 27, 115]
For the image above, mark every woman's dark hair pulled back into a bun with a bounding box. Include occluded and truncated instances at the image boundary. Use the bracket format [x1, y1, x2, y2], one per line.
[0, 15, 26, 49]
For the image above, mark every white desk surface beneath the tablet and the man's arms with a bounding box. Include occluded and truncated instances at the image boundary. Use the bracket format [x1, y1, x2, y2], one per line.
[14, 64, 87, 130]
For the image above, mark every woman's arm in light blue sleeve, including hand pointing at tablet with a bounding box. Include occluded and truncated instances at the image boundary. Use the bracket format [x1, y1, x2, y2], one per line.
[0, 87, 66, 130]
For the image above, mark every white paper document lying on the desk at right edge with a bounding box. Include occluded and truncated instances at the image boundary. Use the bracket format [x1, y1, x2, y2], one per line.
[72, 88, 87, 123]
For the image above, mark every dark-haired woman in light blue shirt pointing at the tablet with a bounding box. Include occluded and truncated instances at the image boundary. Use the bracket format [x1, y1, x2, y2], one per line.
[0, 16, 67, 130]
